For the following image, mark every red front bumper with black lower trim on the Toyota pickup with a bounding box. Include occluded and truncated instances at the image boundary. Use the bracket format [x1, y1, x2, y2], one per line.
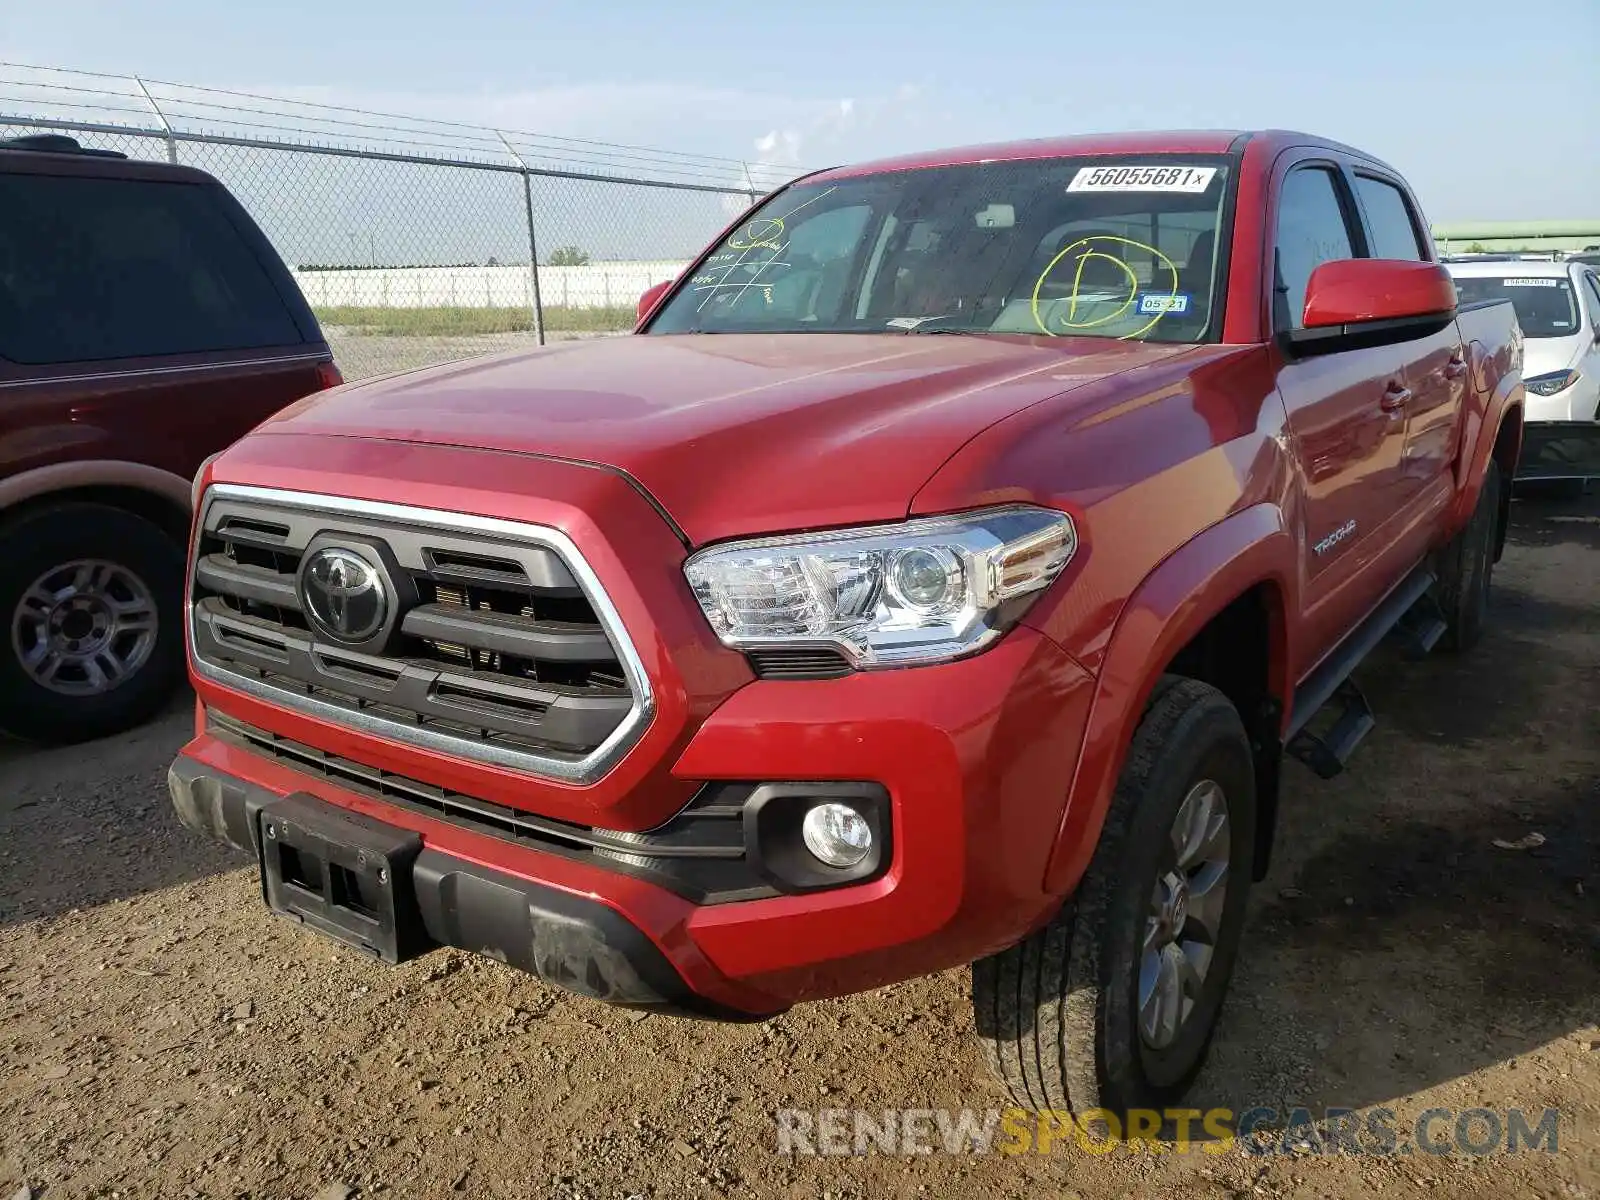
[171, 627, 1093, 1019]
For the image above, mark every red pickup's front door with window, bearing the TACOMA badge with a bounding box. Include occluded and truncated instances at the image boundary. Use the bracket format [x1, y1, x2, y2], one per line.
[1270, 155, 1410, 669]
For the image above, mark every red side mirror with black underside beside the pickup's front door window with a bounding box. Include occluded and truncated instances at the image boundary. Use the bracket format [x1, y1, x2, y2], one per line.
[1286, 258, 1456, 355]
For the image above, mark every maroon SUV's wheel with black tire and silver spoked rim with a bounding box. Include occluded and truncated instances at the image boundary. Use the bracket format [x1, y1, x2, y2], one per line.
[0, 504, 184, 742]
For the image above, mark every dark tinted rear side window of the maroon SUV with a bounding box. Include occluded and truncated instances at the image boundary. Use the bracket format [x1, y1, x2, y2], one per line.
[0, 174, 302, 365]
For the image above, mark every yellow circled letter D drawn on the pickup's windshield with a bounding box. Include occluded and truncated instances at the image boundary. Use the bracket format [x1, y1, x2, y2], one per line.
[1032, 235, 1189, 341]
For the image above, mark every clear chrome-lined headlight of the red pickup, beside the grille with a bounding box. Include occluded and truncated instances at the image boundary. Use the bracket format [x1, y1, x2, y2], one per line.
[683, 506, 1077, 667]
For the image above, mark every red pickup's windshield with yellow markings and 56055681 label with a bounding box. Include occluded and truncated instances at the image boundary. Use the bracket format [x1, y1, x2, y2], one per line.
[648, 155, 1230, 342]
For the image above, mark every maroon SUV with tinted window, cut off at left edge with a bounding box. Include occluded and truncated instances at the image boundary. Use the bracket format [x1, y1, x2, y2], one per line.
[0, 134, 339, 742]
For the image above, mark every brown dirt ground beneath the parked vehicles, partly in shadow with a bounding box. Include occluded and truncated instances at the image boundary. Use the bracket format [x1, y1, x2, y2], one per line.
[0, 483, 1600, 1200]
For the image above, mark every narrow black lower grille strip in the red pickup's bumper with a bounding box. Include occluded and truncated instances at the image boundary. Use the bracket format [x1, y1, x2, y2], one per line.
[206, 710, 779, 904]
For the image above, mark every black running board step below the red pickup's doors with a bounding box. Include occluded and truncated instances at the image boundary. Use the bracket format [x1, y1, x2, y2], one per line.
[1283, 566, 1446, 779]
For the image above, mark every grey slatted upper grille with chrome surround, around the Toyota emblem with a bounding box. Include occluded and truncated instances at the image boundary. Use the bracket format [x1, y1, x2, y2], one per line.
[190, 485, 651, 782]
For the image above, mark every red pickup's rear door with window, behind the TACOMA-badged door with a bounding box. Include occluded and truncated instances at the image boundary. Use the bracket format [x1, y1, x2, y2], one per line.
[1352, 166, 1469, 507]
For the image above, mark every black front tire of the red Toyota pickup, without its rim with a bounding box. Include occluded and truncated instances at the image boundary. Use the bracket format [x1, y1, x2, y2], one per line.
[973, 677, 1256, 1115]
